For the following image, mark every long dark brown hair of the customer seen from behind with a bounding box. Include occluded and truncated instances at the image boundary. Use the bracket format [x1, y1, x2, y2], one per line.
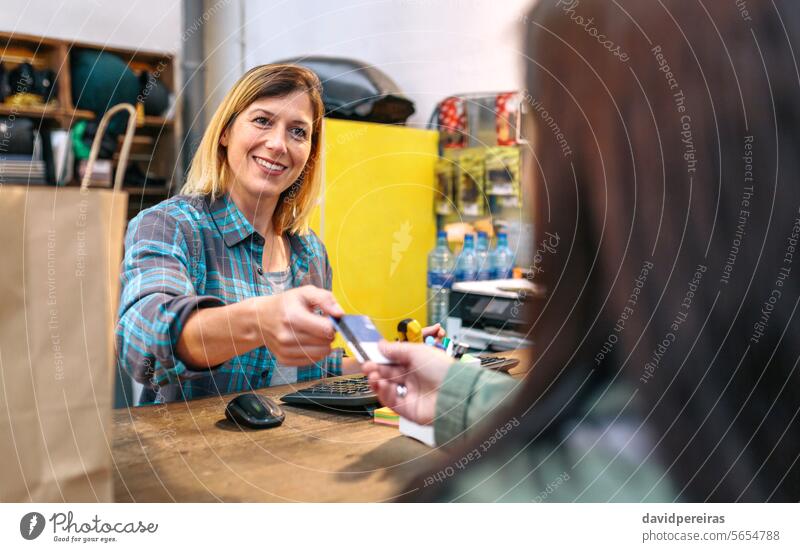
[410, 0, 800, 501]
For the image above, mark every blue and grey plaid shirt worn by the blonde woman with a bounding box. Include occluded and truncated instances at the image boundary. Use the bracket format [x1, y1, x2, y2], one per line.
[116, 194, 342, 404]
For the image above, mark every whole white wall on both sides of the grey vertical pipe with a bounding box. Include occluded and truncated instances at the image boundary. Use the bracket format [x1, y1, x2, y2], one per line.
[6, 0, 533, 125]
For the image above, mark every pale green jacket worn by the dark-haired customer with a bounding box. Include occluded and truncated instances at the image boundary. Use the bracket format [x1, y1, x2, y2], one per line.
[432, 363, 677, 502]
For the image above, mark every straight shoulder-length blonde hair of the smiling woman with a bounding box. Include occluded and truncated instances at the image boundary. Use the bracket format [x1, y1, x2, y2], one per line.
[181, 64, 325, 234]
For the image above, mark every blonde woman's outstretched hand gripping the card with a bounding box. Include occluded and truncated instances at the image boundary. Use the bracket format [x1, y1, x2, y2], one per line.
[255, 286, 344, 366]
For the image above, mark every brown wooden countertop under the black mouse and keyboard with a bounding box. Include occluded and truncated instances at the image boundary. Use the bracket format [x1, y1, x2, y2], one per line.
[113, 351, 530, 502]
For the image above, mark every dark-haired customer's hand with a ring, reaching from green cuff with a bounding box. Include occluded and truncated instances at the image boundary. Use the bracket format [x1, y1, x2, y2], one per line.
[361, 341, 454, 425]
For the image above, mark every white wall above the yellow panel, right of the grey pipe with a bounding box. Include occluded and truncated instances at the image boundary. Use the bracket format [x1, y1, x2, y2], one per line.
[245, 0, 533, 124]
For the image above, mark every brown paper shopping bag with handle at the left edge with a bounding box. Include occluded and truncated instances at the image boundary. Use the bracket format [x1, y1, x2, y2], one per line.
[0, 104, 135, 502]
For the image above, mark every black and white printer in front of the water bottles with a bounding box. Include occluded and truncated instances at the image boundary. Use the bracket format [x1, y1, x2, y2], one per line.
[446, 278, 544, 351]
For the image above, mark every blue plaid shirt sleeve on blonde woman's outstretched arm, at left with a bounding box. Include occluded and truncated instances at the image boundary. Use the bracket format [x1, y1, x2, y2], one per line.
[116, 205, 224, 385]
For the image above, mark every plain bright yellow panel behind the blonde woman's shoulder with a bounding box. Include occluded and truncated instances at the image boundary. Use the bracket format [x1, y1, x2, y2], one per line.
[311, 119, 438, 340]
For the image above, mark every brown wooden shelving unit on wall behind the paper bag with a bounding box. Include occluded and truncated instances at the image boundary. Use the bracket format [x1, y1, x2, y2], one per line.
[0, 32, 181, 218]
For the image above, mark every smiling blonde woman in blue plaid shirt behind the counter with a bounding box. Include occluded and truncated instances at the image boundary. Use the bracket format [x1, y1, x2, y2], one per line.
[116, 65, 344, 404]
